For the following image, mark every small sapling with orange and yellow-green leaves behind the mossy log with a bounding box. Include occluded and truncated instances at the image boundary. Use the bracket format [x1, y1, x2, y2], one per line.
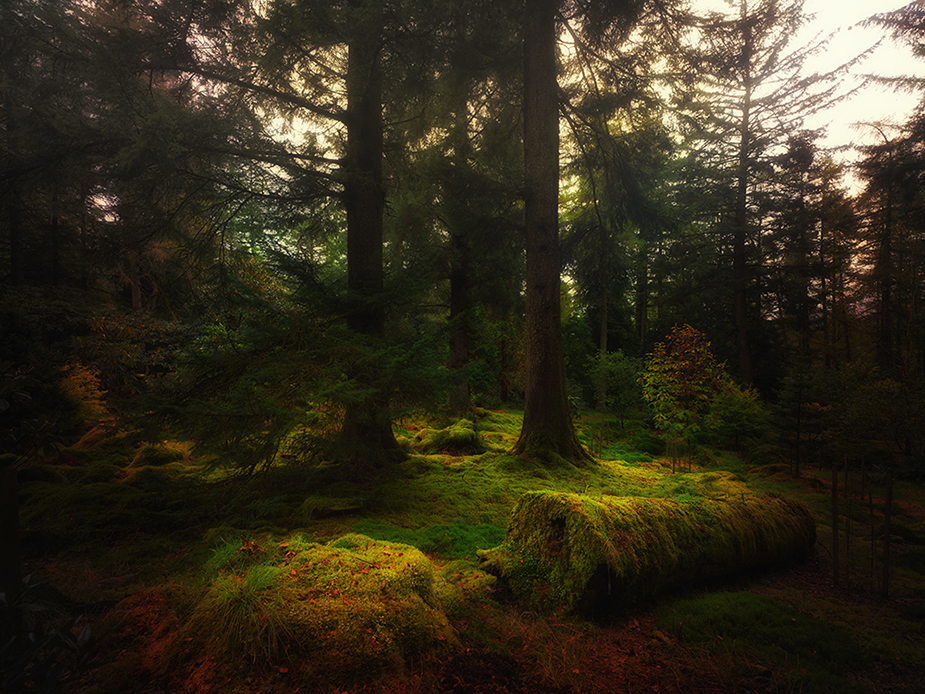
[639, 325, 731, 471]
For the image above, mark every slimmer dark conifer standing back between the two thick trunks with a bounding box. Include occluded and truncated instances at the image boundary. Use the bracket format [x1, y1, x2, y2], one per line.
[387, 0, 523, 414]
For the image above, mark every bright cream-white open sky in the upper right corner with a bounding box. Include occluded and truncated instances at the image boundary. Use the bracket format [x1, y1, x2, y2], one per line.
[695, 0, 925, 167]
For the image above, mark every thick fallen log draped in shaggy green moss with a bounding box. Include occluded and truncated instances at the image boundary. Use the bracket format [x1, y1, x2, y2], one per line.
[480, 492, 816, 614]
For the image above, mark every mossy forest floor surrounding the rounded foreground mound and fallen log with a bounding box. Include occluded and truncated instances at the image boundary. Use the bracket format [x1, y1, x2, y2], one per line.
[12, 413, 925, 694]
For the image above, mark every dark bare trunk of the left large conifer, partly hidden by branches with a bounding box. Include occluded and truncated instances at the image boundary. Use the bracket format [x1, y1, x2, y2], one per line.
[338, 0, 404, 467]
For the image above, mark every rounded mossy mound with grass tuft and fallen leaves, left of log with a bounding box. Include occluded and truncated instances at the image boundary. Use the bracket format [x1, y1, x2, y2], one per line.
[188, 534, 457, 684]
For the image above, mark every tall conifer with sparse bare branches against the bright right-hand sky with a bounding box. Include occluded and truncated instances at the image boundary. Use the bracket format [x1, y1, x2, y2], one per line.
[682, 0, 865, 384]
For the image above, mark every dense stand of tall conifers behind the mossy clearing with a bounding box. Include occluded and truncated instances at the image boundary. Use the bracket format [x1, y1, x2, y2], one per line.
[0, 0, 925, 469]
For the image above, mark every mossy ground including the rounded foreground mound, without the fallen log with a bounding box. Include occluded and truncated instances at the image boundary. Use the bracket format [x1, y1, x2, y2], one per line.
[14, 410, 925, 694]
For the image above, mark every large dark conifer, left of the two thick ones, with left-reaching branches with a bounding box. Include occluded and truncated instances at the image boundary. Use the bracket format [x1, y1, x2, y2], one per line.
[125, 0, 436, 467]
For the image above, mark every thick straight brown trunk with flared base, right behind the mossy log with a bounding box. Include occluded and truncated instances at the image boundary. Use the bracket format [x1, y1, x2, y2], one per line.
[513, 0, 591, 461]
